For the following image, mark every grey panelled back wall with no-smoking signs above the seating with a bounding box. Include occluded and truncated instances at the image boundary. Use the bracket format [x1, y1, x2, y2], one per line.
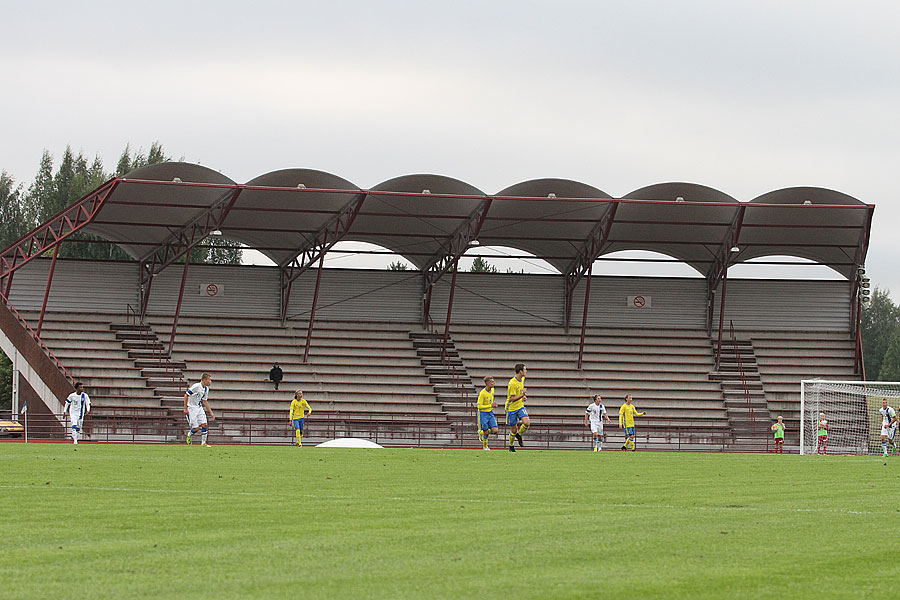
[10, 260, 850, 331]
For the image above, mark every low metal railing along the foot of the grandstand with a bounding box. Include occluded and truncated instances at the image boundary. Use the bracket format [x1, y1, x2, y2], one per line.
[0, 408, 794, 452]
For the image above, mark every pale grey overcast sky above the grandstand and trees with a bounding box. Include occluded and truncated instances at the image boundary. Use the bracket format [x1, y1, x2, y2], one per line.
[0, 0, 900, 292]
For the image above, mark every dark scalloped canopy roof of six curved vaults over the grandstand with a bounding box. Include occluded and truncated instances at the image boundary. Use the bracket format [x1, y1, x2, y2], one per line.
[56, 162, 874, 277]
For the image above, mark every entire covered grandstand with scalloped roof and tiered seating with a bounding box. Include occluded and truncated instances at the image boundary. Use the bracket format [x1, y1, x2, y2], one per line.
[0, 162, 874, 450]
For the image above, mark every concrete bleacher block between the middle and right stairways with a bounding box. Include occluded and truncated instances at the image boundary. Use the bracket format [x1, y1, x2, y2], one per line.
[451, 325, 728, 446]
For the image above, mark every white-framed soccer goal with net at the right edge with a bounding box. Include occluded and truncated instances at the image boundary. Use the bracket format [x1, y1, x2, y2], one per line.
[800, 379, 900, 454]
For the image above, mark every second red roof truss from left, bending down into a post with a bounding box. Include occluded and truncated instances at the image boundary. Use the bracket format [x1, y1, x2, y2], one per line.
[141, 186, 244, 323]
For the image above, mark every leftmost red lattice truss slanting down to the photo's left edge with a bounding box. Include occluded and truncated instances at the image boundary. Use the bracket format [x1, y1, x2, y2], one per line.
[0, 179, 120, 290]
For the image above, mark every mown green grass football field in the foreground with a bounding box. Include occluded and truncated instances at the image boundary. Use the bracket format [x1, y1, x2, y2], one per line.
[0, 443, 900, 600]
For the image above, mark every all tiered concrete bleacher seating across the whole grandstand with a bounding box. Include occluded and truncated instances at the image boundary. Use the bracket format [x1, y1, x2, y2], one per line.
[15, 304, 856, 448]
